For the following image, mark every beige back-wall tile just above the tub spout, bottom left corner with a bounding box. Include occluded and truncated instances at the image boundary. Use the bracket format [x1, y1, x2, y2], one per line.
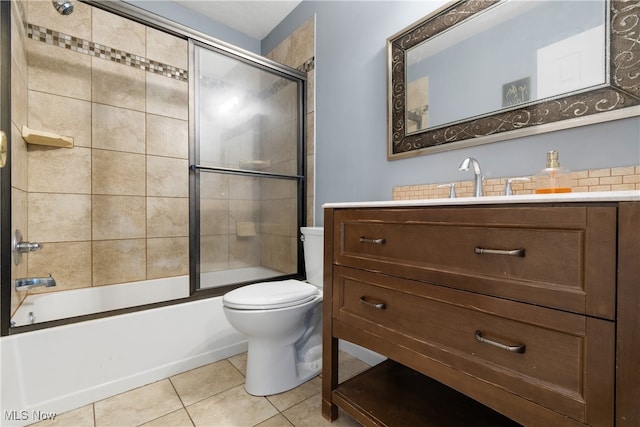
[28, 242, 91, 292]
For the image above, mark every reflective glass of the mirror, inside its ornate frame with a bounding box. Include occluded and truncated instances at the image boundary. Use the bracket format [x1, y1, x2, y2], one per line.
[406, 1, 606, 133]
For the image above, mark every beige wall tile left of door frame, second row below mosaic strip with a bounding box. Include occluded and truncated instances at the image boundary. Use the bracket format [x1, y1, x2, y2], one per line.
[147, 114, 189, 159]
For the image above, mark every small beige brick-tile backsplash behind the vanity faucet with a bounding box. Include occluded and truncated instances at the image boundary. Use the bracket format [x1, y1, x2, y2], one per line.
[392, 166, 640, 200]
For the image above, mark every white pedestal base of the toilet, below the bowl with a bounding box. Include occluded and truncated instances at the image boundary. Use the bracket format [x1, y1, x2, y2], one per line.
[244, 340, 322, 396]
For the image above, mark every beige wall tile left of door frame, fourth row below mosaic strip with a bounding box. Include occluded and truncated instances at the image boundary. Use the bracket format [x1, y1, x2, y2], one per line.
[147, 197, 189, 238]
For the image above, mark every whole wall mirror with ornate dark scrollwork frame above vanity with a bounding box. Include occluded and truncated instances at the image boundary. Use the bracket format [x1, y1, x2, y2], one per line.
[387, 0, 640, 159]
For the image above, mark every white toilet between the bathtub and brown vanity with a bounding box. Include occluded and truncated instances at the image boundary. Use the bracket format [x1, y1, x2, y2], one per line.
[222, 227, 324, 396]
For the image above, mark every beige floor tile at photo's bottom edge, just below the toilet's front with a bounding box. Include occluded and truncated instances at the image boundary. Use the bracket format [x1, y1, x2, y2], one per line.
[187, 386, 278, 427]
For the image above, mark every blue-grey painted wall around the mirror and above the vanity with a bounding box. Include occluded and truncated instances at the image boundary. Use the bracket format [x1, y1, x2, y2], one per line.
[262, 0, 640, 224]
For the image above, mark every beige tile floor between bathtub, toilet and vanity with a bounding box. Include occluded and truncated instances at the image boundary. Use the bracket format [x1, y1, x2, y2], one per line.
[32, 352, 368, 427]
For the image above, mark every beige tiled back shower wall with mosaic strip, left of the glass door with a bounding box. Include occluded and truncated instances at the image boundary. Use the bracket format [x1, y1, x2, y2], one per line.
[13, 1, 189, 300]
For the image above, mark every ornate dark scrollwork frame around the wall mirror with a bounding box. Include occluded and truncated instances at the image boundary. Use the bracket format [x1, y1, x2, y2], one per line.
[387, 0, 640, 160]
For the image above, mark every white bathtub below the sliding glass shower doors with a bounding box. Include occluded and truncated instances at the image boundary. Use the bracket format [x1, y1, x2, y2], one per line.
[0, 276, 247, 426]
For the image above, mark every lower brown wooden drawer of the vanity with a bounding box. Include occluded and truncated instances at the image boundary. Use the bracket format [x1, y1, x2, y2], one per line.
[332, 267, 615, 425]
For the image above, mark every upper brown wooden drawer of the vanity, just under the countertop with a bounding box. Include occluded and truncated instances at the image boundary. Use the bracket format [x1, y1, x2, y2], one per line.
[333, 206, 616, 319]
